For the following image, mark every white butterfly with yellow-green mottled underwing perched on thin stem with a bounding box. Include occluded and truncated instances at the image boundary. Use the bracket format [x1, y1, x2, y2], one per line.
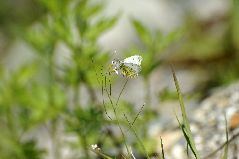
[111, 55, 143, 78]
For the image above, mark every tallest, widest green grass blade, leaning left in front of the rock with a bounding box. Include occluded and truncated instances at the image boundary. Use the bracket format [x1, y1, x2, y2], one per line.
[171, 66, 200, 159]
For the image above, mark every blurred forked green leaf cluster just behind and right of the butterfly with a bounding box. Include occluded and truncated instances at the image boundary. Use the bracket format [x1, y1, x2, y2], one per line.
[132, 19, 183, 79]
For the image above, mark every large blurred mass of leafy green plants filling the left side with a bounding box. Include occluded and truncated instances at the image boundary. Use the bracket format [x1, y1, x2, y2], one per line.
[0, 0, 118, 158]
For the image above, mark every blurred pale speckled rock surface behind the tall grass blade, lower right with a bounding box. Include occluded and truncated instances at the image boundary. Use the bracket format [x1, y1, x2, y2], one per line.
[158, 83, 239, 159]
